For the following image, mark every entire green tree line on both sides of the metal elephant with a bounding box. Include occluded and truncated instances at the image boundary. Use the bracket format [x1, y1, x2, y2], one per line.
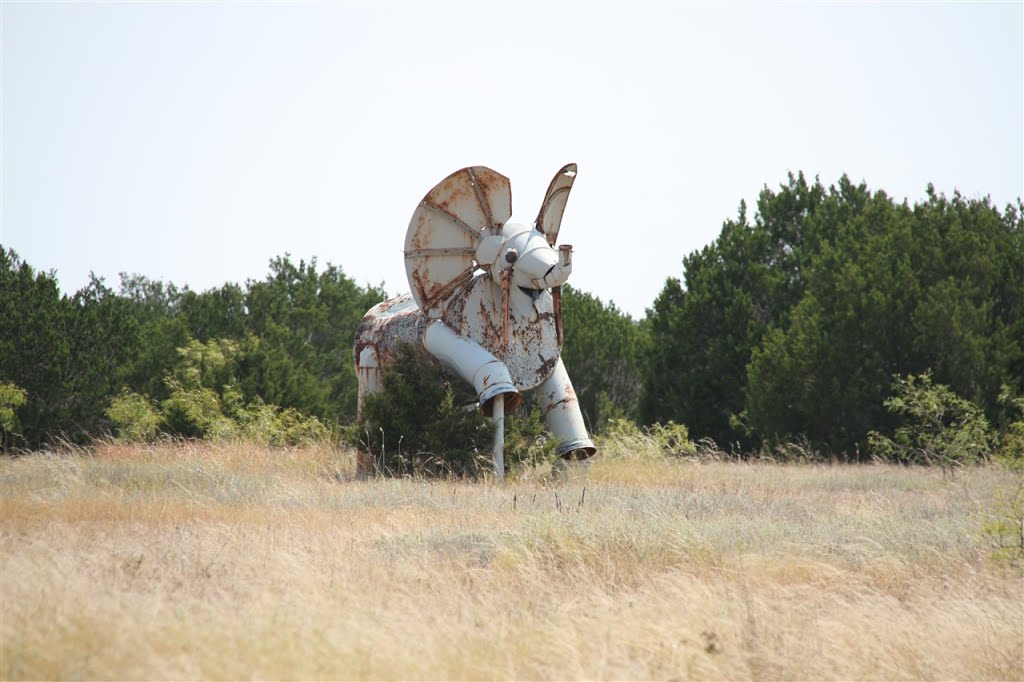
[0, 174, 1024, 457]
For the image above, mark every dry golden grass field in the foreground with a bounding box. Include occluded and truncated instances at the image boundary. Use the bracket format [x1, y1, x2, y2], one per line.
[0, 443, 1024, 680]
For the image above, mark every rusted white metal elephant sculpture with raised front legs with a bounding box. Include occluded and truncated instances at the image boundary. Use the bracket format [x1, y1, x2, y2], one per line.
[354, 164, 596, 478]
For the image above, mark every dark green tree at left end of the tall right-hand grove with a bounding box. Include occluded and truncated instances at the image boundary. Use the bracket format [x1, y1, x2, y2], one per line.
[641, 174, 828, 445]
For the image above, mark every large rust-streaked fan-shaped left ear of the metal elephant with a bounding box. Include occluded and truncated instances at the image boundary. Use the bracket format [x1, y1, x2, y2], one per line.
[404, 166, 512, 318]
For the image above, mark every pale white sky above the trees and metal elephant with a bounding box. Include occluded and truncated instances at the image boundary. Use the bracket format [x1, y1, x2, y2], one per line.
[0, 1, 1024, 316]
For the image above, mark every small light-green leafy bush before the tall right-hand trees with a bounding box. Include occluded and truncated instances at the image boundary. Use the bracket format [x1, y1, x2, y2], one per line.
[868, 372, 993, 471]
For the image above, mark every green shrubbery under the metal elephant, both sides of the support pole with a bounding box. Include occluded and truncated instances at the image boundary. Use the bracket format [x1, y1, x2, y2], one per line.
[358, 345, 553, 477]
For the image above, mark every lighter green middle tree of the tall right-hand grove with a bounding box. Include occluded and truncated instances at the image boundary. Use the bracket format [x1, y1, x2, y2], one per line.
[744, 182, 918, 451]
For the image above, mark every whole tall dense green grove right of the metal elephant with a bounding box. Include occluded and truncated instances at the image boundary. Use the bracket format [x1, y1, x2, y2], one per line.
[642, 175, 1024, 453]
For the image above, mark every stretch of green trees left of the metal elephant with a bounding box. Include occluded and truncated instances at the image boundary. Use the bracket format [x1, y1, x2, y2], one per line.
[0, 249, 385, 447]
